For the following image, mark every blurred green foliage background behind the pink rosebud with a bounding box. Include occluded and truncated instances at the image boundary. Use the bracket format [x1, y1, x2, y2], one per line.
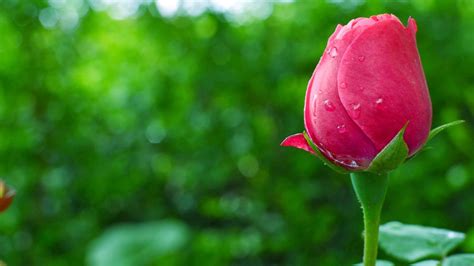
[0, 0, 474, 266]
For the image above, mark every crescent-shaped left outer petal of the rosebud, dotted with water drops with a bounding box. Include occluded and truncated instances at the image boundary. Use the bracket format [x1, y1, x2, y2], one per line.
[305, 20, 376, 168]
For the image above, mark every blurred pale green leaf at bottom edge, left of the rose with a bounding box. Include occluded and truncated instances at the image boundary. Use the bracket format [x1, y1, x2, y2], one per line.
[87, 220, 189, 266]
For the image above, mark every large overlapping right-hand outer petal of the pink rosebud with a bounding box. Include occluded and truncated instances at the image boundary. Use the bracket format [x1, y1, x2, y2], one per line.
[338, 19, 431, 155]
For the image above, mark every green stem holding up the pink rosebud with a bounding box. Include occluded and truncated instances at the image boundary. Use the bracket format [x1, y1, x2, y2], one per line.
[351, 172, 388, 266]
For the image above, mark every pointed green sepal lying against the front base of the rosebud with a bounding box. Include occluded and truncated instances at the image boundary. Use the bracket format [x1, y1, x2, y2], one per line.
[367, 123, 408, 173]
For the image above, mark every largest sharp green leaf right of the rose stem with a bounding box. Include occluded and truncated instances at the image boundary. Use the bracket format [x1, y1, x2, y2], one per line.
[379, 222, 465, 262]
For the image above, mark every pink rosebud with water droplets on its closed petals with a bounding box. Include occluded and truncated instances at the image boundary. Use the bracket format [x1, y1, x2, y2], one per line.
[282, 14, 432, 169]
